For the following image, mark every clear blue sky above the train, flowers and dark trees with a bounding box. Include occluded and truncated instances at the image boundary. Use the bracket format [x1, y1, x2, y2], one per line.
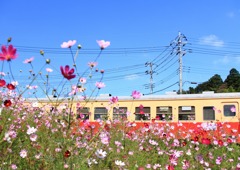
[0, 0, 240, 96]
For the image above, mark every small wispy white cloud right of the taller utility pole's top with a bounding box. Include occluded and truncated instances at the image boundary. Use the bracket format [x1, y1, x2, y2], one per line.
[199, 34, 224, 47]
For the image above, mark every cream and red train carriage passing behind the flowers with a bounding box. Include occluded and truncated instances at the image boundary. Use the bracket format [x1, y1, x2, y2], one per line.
[26, 91, 240, 142]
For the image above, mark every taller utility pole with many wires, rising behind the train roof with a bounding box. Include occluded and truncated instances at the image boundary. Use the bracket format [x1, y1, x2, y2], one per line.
[176, 32, 187, 94]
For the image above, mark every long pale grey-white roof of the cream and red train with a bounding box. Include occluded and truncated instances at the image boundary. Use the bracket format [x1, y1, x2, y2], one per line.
[26, 92, 240, 102]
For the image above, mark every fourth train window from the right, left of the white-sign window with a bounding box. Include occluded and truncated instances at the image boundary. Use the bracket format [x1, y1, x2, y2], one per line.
[156, 106, 172, 120]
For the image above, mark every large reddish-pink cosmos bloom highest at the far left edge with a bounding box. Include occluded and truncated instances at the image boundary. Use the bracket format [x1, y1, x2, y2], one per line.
[0, 45, 17, 61]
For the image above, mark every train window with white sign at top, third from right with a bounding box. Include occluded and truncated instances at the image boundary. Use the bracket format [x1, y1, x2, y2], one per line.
[178, 106, 195, 120]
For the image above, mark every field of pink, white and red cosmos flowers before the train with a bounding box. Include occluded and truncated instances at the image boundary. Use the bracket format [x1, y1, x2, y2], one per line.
[0, 39, 240, 170]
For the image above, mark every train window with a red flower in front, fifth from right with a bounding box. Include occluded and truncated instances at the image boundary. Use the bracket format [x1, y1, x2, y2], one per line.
[135, 105, 151, 120]
